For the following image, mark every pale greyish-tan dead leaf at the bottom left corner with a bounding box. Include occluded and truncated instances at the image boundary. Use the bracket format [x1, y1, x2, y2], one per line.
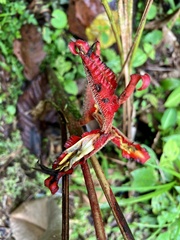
[10, 197, 62, 240]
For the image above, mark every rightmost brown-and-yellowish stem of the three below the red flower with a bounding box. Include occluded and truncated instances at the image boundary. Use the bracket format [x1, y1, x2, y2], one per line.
[91, 156, 134, 240]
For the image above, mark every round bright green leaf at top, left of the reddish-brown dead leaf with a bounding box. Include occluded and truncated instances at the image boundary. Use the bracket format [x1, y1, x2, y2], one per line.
[51, 9, 67, 29]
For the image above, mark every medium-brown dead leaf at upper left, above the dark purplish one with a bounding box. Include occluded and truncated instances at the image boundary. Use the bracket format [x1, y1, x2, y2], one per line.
[13, 24, 46, 80]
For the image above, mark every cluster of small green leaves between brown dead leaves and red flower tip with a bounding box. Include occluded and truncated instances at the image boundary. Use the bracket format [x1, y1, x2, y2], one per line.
[42, 9, 80, 95]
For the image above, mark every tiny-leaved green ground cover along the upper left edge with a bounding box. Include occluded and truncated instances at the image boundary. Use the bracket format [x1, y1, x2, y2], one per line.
[0, 1, 37, 124]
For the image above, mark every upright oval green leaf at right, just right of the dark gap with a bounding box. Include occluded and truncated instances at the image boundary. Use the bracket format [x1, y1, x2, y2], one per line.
[161, 108, 177, 130]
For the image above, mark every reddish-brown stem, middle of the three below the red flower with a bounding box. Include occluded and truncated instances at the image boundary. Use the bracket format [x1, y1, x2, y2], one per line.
[81, 162, 106, 240]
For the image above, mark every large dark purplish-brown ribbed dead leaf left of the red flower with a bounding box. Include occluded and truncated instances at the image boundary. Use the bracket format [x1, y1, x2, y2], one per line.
[17, 74, 60, 157]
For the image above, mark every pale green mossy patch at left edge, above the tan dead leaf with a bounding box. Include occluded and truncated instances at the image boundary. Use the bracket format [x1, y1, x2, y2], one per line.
[0, 131, 44, 202]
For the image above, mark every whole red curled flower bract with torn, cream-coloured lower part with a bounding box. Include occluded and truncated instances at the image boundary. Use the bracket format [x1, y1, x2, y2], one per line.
[41, 40, 150, 194]
